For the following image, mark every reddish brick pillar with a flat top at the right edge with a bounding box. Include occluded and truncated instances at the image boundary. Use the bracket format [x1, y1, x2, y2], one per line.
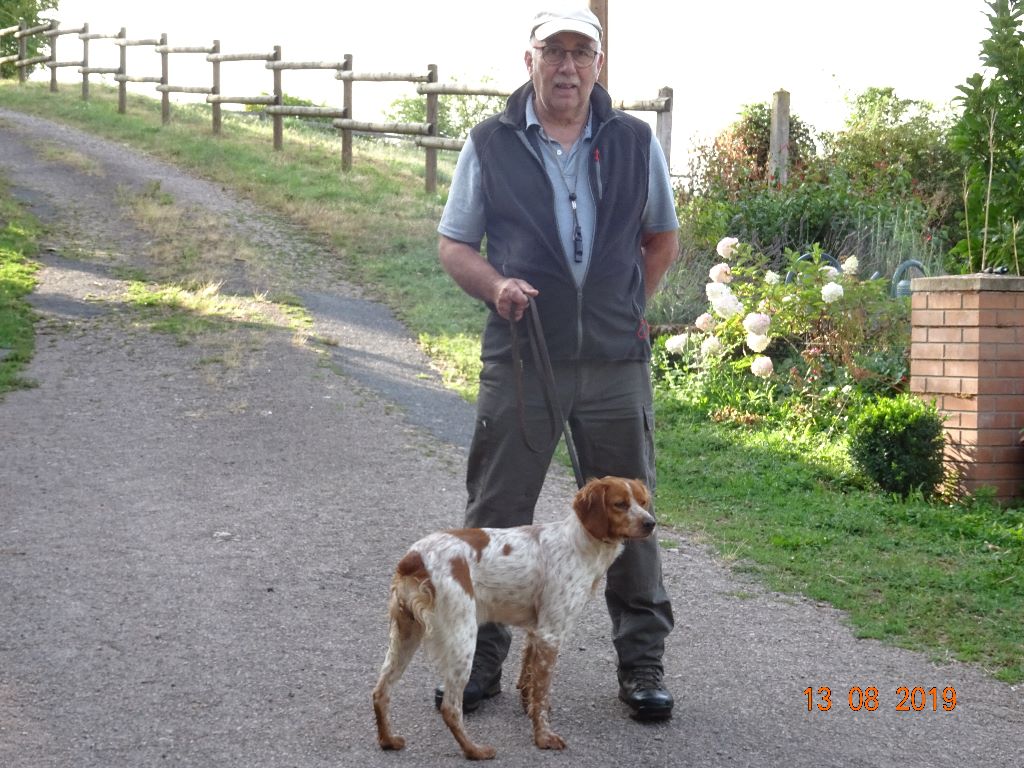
[910, 274, 1024, 502]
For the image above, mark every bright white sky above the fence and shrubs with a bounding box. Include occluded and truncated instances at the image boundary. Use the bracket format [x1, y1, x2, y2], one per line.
[49, 0, 988, 171]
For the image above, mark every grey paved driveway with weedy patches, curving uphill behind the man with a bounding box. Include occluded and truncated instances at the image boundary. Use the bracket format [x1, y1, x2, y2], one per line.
[0, 109, 1024, 768]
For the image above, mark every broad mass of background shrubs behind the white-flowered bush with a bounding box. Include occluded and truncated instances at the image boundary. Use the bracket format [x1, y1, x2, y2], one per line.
[680, 88, 959, 274]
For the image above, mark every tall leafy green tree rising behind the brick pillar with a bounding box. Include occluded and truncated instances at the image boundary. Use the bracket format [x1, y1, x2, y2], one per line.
[950, 0, 1024, 274]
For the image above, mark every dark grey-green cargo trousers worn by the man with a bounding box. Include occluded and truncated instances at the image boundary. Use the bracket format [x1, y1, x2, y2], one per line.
[466, 361, 674, 681]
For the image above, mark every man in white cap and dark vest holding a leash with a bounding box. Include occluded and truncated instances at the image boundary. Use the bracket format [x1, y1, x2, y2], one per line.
[438, 8, 679, 720]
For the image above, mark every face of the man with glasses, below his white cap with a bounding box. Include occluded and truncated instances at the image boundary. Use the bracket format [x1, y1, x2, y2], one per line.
[526, 32, 604, 119]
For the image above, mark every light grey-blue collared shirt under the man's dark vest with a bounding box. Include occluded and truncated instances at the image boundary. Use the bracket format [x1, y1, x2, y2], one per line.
[437, 98, 679, 285]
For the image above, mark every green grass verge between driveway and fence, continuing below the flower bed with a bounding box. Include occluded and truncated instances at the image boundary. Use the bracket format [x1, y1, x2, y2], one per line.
[0, 79, 1024, 682]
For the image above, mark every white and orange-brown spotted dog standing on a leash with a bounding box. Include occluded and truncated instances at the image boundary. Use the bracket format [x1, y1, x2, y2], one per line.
[374, 477, 654, 760]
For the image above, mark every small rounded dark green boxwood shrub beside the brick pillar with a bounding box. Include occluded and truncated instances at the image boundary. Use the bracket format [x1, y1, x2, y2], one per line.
[850, 393, 943, 498]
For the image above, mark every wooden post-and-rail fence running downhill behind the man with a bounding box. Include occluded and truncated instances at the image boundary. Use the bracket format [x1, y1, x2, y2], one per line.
[0, 20, 673, 193]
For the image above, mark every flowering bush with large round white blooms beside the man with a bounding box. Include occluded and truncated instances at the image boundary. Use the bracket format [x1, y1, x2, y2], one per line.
[654, 238, 909, 431]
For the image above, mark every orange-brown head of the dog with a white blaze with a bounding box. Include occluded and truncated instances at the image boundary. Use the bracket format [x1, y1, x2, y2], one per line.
[572, 476, 654, 542]
